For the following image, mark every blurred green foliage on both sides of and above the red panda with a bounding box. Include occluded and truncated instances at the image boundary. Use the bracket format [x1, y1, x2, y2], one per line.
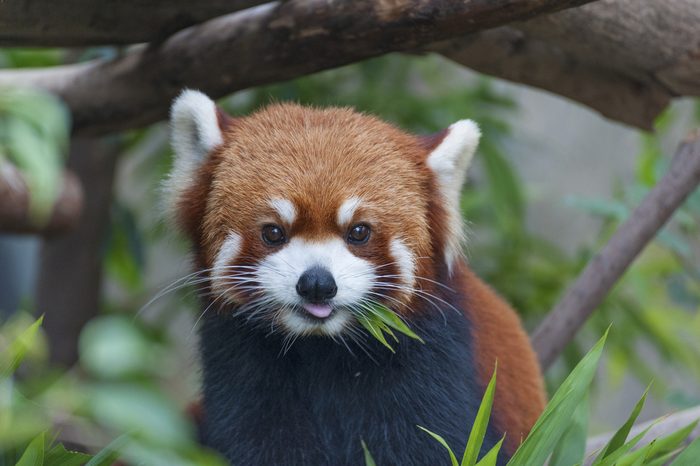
[0, 49, 700, 465]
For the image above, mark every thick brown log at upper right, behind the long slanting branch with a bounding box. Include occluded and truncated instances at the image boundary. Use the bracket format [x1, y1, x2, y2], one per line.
[429, 0, 700, 129]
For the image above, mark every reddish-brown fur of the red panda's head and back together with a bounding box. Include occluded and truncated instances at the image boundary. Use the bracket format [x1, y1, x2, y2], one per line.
[178, 105, 545, 451]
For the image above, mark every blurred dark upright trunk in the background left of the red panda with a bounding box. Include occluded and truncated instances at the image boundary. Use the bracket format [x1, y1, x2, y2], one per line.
[36, 138, 119, 366]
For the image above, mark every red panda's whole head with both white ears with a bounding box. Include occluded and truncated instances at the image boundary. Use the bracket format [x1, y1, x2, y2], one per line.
[165, 91, 479, 335]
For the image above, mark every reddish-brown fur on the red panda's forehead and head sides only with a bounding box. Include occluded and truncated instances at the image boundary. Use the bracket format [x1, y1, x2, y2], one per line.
[179, 105, 443, 311]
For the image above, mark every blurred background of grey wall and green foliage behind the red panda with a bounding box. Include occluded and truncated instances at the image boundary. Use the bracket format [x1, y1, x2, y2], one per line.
[0, 48, 700, 464]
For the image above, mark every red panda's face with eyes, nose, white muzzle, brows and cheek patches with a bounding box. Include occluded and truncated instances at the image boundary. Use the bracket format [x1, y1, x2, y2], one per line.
[205, 197, 415, 335]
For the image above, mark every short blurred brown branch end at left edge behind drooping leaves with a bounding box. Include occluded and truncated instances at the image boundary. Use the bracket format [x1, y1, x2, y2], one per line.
[0, 161, 83, 235]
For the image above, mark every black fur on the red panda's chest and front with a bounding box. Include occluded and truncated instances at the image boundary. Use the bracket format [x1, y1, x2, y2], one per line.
[201, 296, 506, 466]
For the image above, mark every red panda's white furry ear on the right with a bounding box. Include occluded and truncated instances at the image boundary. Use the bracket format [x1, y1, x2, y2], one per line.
[426, 120, 481, 270]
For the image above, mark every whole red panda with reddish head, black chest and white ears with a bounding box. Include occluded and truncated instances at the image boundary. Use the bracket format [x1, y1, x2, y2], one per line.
[165, 90, 545, 466]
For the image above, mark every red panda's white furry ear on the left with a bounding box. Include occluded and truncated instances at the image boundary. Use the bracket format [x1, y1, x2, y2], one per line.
[163, 89, 223, 213]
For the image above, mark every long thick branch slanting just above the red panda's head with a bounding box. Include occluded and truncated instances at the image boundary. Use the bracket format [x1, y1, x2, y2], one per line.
[0, 0, 591, 137]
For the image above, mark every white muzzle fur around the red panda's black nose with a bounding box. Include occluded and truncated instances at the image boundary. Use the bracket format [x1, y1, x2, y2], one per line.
[257, 238, 376, 335]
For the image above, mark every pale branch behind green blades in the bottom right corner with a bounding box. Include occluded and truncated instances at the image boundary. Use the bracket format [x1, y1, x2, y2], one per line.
[583, 406, 700, 466]
